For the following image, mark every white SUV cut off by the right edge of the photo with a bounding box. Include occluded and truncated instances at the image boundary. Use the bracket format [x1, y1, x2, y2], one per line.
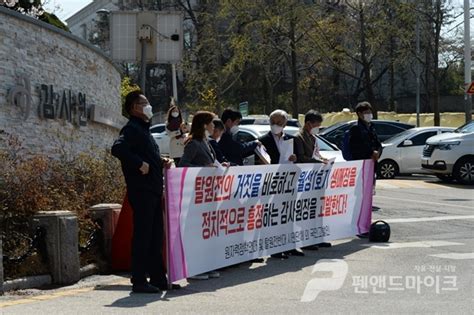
[421, 121, 474, 185]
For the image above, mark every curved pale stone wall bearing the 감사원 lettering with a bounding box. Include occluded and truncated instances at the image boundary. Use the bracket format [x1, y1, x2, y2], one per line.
[0, 8, 125, 156]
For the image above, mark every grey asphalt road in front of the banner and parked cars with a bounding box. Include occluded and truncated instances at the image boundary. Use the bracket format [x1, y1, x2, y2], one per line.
[0, 176, 474, 314]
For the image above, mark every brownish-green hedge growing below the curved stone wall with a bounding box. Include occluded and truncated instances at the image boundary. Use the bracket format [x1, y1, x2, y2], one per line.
[0, 133, 125, 277]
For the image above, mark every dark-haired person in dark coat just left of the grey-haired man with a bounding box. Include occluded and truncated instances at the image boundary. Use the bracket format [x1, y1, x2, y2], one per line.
[219, 108, 260, 165]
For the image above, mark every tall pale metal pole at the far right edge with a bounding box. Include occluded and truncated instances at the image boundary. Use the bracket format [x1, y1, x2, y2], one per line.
[464, 0, 472, 122]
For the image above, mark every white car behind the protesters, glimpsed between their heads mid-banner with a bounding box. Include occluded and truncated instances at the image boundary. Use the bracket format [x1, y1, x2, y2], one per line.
[235, 125, 345, 165]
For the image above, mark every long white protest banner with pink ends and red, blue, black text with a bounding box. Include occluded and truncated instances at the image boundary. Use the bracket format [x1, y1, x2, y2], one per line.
[166, 160, 374, 281]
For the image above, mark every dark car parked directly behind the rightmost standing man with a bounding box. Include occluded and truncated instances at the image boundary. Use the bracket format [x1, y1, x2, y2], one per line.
[319, 120, 415, 148]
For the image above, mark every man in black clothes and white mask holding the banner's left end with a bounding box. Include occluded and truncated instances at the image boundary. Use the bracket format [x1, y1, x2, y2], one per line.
[112, 91, 179, 293]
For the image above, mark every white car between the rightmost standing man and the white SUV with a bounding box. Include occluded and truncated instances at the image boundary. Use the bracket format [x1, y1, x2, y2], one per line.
[377, 127, 454, 179]
